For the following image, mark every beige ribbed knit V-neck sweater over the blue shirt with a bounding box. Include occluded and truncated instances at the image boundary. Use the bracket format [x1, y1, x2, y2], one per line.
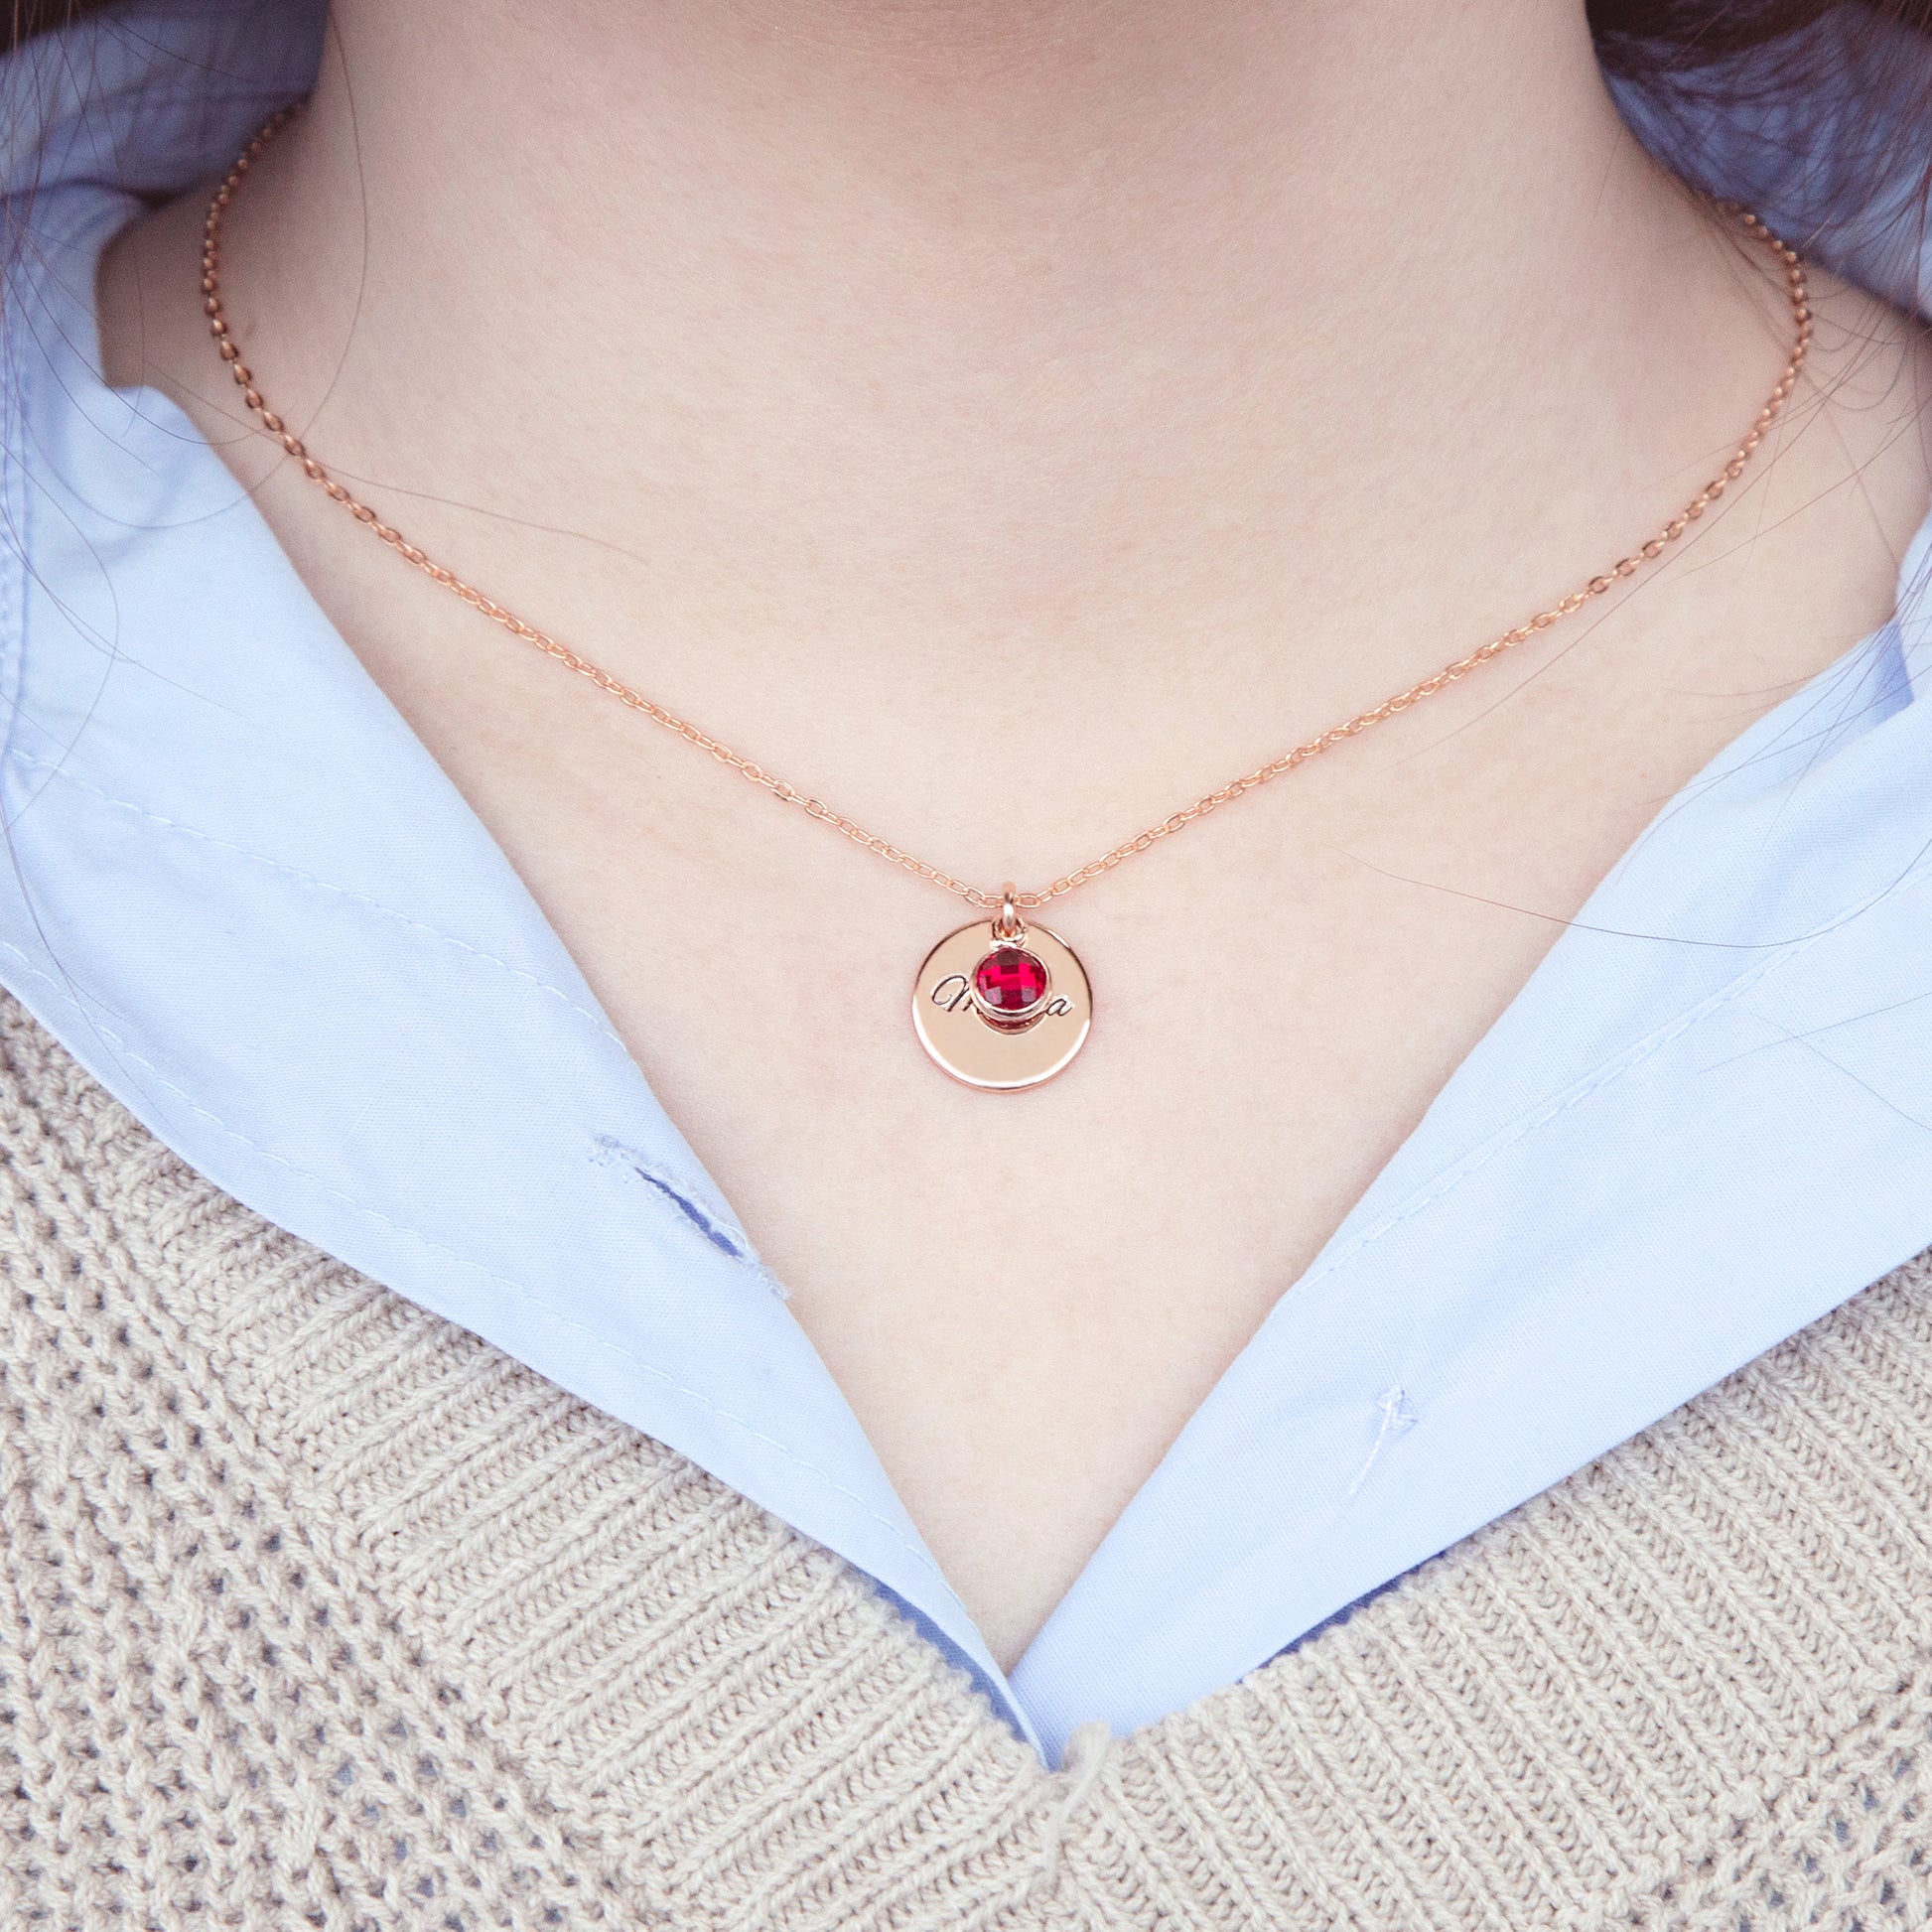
[0, 1003, 1932, 1932]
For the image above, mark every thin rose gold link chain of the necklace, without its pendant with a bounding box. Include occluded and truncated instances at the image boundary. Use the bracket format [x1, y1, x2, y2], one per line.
[201, 108, 1812, 908]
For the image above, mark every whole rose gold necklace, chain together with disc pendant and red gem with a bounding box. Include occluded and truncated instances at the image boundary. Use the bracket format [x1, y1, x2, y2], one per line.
[201, 108, 1812, 1093]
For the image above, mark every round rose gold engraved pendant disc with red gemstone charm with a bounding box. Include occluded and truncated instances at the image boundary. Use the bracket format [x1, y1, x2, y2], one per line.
[912, 919, 1093, 1093]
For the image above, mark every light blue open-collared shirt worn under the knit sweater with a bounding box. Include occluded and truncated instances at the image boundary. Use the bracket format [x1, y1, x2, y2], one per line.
[11, 0, 1932, 1758]
